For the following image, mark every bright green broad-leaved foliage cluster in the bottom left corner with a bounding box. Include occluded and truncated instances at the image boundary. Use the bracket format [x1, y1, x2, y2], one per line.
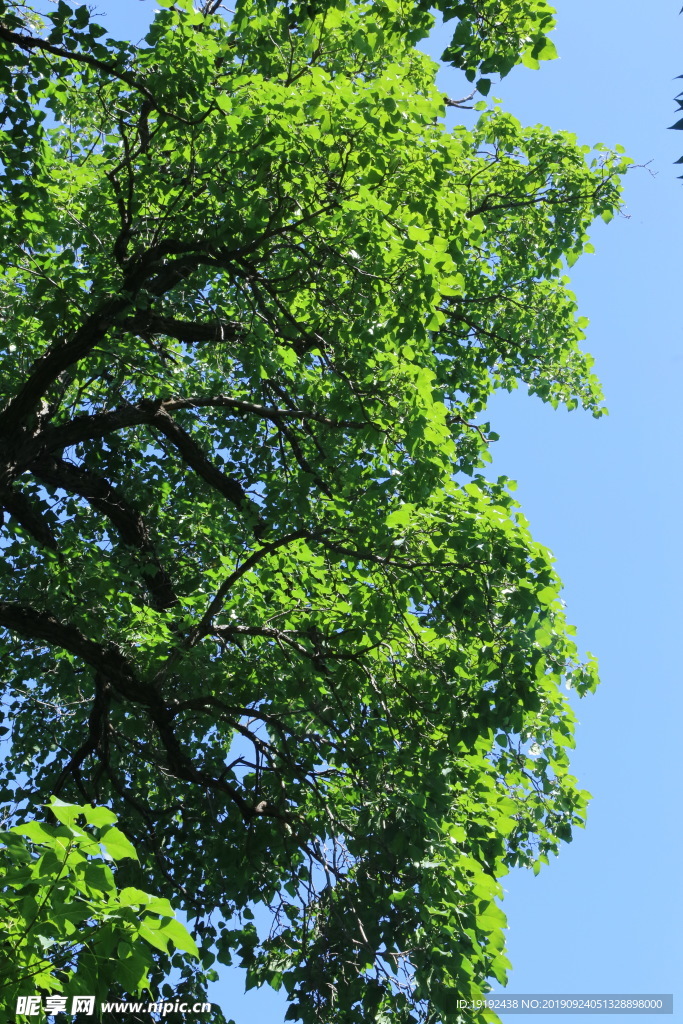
[0, 800, 198, 1024]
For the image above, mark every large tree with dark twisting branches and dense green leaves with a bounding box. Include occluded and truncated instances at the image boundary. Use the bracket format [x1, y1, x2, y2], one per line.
[0, 0, 628, 1024]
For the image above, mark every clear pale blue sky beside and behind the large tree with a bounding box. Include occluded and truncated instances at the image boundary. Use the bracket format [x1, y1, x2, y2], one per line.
[28, 0, 683, 1024]
